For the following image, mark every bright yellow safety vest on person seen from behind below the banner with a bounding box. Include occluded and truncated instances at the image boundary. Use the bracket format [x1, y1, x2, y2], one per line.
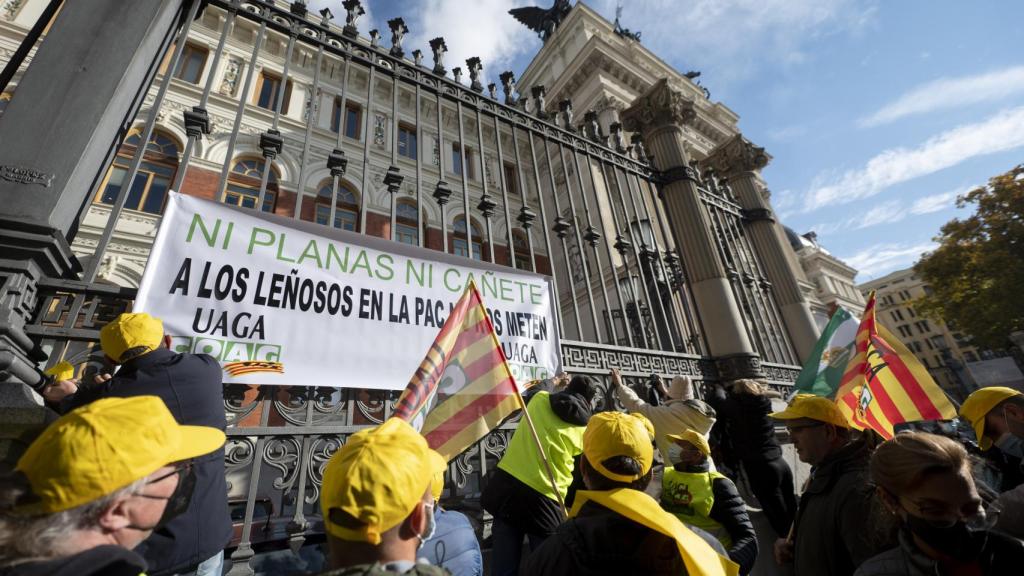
[498, 392, 587, 501]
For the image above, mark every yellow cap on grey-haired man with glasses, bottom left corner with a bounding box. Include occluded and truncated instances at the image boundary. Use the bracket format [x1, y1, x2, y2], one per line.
[14, 396, 224, 515]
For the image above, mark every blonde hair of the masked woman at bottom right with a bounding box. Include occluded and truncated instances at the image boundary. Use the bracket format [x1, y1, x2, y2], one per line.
[871, 431, 971, 495]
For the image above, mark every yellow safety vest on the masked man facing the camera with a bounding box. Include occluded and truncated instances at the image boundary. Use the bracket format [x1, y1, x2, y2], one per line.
[662, 467, 732, 549]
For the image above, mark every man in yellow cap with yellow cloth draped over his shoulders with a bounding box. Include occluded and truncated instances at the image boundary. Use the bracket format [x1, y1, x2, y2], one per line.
[524, 412, 738, 576]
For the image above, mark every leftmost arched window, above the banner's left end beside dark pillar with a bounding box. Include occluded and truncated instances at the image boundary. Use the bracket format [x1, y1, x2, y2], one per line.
[95, 129, 178, 214]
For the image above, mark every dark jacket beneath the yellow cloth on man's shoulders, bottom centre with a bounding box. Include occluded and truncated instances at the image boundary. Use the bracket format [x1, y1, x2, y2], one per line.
[522, 502, 687, 576]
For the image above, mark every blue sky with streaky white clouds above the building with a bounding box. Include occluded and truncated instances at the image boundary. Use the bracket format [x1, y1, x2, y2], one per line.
[311, 0, 1024, 282]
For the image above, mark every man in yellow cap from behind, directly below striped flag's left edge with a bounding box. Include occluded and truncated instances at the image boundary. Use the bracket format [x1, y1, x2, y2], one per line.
[321, 418, 447, 576]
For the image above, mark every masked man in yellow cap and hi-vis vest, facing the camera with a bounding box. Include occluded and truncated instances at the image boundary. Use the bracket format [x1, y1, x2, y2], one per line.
[662, 430, 758, 574]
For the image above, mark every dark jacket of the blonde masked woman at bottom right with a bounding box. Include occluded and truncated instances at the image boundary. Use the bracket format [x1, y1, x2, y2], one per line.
[854, 531, 1024, 576]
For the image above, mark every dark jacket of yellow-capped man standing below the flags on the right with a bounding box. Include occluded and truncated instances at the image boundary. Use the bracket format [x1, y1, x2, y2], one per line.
[794, 441, 878, 576]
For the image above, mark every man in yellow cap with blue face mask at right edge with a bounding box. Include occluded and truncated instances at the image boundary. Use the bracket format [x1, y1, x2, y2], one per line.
[959, 386, 1024, 538]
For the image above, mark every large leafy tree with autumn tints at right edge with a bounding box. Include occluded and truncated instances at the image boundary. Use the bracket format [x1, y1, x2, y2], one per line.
[914, 164, 1024, 349]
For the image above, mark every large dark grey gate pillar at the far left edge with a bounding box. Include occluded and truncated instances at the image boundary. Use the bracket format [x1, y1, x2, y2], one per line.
[0, 0, 190, 468]
